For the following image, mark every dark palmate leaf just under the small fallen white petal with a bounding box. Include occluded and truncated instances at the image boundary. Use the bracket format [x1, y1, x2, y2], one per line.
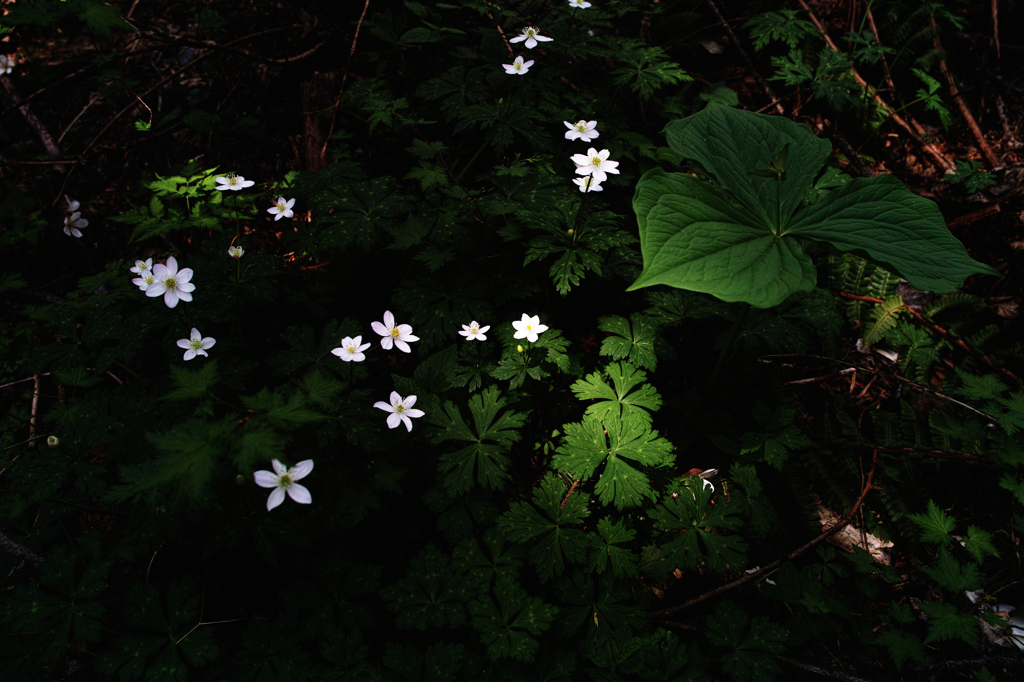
[650, 485, 746, 572]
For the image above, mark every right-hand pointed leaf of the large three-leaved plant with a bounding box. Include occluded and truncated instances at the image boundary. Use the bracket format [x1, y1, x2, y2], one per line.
[785, 175, 999, 294]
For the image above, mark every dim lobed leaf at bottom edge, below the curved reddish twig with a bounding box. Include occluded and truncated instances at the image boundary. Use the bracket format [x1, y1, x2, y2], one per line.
[708, 599, 790, 682]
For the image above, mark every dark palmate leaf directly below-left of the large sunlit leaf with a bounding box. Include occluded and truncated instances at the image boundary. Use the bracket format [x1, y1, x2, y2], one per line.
[498, 473, 590, 581]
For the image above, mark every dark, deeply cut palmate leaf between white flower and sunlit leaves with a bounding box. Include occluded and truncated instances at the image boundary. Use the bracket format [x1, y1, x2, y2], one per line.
[428, 386, 526, 495]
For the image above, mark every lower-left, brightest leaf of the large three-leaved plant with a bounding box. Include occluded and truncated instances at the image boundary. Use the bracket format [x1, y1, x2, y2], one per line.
[630, 168, 815, 308]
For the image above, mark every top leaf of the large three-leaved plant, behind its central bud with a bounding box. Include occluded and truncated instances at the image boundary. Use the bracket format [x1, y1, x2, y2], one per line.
[665, 102, 831, 225]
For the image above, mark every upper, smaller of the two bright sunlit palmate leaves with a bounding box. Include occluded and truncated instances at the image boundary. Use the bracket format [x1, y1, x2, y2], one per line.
[570, 363, 662, 422]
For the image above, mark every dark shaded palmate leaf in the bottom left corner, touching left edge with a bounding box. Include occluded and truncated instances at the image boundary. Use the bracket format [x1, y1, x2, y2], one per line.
[2, 545, 111, 665]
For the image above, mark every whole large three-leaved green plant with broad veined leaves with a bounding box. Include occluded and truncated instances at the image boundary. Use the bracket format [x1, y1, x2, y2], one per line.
[631, 102, 998, 308]
